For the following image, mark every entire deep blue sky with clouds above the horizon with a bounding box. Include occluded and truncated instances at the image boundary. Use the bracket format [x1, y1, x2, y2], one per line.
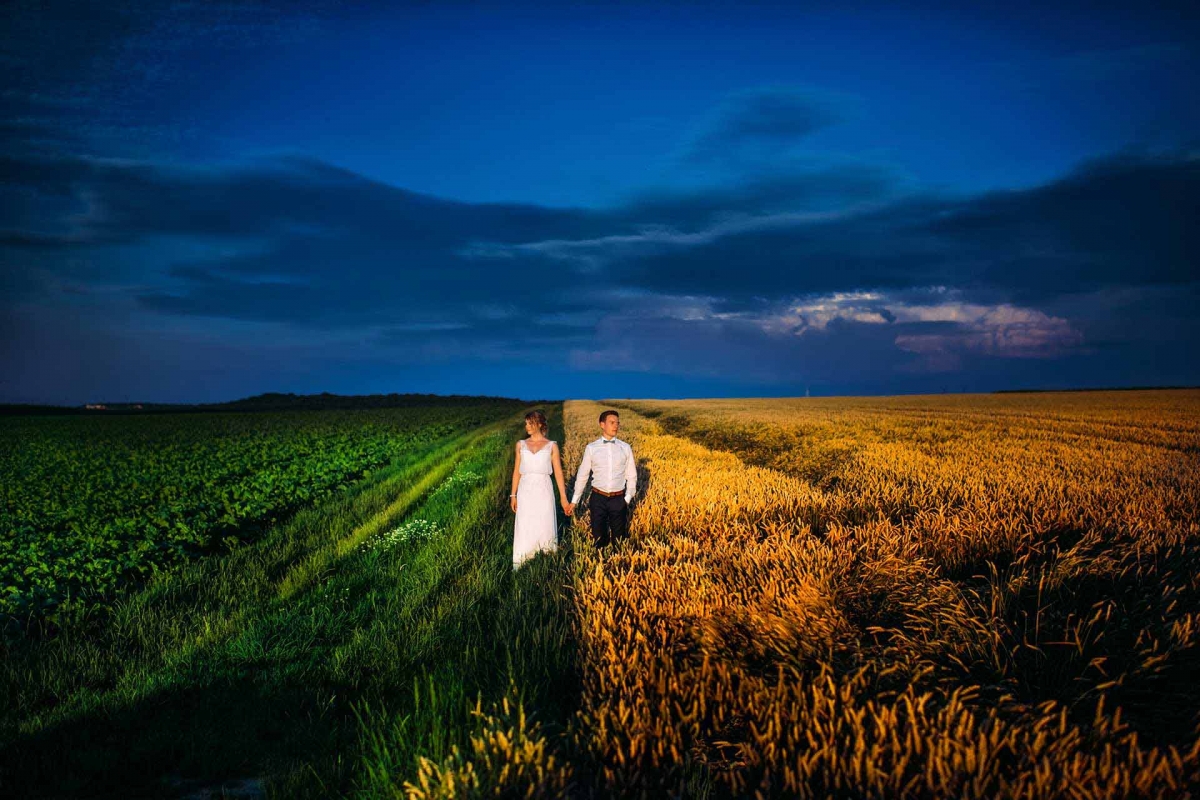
[0, 1, 1200, 404]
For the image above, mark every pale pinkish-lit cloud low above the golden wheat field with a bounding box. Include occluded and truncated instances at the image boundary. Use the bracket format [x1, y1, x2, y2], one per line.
[559, 287, 1085, 379]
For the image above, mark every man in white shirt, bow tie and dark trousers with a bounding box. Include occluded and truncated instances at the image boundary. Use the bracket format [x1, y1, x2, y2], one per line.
[566, 410, 637, 547]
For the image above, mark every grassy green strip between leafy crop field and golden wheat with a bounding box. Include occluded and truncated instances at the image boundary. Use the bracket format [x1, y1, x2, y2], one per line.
[0, 405, 577, 798]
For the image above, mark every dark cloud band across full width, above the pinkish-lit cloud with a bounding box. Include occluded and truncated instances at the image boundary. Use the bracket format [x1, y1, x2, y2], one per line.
[0, 145, 1200, 327]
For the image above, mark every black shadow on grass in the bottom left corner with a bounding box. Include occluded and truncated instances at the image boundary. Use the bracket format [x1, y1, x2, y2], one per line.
[2, 673, 355, 799]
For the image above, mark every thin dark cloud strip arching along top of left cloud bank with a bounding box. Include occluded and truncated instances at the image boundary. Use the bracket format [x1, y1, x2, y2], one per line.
[0, 156, 614, 247]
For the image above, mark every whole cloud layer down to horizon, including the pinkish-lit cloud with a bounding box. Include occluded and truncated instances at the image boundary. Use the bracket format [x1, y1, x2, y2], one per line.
[0, 140, 1200, 400]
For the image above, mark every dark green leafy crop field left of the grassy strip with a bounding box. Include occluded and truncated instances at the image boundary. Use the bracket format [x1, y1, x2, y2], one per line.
[0, 403, 520, 631]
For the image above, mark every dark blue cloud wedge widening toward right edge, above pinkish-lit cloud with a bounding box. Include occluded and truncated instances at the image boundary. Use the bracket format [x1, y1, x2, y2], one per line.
[523, 145, 1200, 303]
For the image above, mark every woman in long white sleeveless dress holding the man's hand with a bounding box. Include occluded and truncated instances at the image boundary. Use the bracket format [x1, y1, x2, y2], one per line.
[509, 411, 571, 570]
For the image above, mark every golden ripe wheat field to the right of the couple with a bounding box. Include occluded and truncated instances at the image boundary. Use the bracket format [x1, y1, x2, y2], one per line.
[564, 391, 1200, 798]
